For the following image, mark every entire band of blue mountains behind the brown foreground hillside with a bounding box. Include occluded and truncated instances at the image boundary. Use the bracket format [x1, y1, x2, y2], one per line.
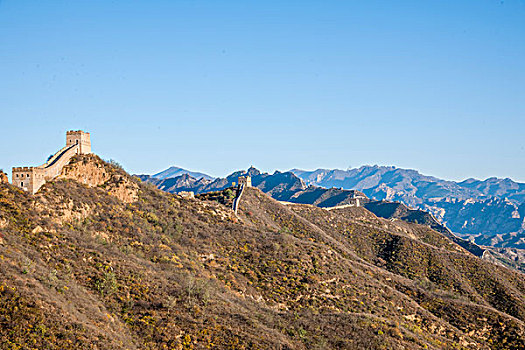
[139, 166, 525, 248]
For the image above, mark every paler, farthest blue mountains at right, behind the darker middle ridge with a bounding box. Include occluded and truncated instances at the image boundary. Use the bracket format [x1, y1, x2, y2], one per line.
[291, 166, 525, 248]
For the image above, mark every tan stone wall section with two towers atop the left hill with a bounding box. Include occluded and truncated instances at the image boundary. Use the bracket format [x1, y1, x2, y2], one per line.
[11, 130, 91, 194]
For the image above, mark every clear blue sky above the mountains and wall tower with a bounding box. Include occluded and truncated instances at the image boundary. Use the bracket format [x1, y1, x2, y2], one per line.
[0, 0, 525, 182]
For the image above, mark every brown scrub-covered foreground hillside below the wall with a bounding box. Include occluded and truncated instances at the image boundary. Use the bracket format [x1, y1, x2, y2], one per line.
[0, 155, 525, 349]
